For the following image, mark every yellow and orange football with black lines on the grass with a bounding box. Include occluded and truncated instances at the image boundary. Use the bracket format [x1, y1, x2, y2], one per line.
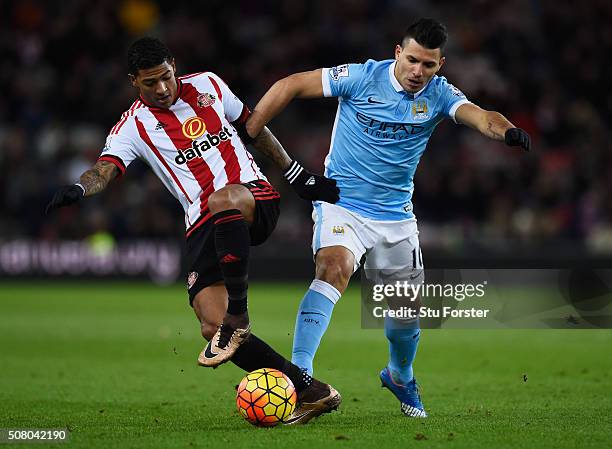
[236, 368, 297, 427]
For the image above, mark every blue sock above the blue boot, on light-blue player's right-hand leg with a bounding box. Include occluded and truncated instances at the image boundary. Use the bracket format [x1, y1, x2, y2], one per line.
[385, 317, 421, 385]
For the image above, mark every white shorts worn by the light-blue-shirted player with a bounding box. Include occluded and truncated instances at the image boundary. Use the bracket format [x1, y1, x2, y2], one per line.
[312, 201, 423, 279]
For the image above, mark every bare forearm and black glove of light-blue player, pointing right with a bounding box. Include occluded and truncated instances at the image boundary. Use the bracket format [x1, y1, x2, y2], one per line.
[455, 103, 531, 151]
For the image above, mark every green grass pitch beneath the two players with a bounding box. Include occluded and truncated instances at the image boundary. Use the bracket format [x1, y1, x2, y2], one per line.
[0, 281, 612, 449]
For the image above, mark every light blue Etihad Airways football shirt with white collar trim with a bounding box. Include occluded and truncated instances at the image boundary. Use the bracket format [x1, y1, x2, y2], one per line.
[322, 59, 469, 221]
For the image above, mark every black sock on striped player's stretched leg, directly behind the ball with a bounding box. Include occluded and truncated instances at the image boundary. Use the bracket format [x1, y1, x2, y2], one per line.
[231, 334, 312, 393]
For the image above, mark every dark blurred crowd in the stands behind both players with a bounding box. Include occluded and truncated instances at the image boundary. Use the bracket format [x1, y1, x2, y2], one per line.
[0, 0, 612, 256]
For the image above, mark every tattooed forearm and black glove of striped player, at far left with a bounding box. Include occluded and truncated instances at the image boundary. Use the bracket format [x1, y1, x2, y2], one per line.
[45, 161, 119, 214]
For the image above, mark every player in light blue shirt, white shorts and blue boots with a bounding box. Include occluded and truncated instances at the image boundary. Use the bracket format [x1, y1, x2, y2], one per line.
[247, 19, 531, 417]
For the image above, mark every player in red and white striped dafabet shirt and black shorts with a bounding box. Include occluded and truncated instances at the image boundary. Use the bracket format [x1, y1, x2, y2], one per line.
[47, 38, 341, 424]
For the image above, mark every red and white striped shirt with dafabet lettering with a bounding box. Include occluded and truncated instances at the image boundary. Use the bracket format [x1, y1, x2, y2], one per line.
[99, 72, 266, 235]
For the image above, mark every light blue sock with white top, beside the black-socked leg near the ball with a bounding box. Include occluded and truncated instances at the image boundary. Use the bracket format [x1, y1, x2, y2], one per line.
[291, 279, 340, 376]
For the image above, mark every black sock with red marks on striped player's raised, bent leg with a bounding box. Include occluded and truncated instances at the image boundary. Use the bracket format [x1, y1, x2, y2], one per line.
[212, 209, 251, 315]
